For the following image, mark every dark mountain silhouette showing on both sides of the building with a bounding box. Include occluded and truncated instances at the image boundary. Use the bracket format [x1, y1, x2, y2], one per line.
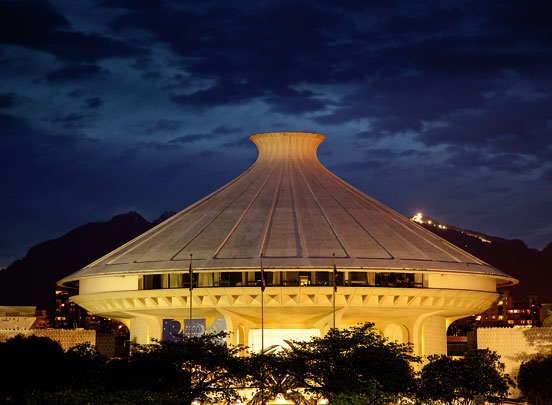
[0, 212, 552, 309]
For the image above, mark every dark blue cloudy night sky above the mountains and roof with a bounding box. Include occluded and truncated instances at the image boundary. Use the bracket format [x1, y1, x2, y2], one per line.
[0, 0, 552, 267]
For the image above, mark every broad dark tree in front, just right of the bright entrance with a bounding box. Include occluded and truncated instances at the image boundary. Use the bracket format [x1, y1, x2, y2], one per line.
[284, 323, 419, 404]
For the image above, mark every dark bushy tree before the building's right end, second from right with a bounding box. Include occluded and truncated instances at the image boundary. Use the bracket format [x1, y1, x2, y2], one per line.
[418, 349, 514, 405]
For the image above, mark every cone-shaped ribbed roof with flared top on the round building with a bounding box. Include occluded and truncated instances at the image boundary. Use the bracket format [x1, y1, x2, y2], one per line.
[61, 132, 513, 283]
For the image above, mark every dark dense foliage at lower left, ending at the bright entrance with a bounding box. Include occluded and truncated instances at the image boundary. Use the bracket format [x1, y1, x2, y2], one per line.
[0, 333, 247, 404]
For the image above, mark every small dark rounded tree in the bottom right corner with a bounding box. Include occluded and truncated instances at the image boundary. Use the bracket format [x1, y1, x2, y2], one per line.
[517, 355, 552, 405]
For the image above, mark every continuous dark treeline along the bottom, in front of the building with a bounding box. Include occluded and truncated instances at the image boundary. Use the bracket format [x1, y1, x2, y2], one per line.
[0, 323, 512, 405]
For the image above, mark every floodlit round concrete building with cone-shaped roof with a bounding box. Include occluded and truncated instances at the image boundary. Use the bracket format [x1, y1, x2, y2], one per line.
[60, 132, 517, 355]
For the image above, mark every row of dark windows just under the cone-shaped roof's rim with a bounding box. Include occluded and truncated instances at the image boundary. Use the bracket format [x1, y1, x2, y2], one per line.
[138, 271, 423, 290]
